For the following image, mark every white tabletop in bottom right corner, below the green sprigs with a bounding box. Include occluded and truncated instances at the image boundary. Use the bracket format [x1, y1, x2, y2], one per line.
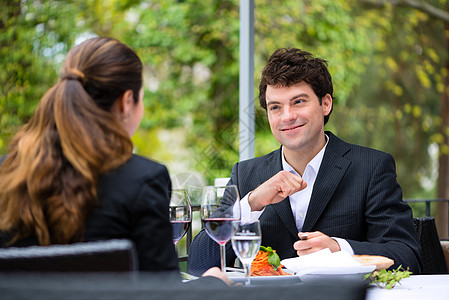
[366, 275, 449, 300]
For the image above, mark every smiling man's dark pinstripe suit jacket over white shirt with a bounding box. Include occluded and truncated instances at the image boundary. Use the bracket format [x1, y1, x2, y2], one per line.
[189, 132, 421, 274]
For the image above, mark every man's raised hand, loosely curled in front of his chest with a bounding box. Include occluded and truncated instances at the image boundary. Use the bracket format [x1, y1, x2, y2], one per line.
[248, 171, 307, 211]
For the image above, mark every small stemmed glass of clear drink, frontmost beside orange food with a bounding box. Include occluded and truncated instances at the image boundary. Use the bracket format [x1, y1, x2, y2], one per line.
[231, 220, 262, 285]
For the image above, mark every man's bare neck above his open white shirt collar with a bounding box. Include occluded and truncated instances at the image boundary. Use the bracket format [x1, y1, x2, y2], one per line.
[283, 133, 326, 176]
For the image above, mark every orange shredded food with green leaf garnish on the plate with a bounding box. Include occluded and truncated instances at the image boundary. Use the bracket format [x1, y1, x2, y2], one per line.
[250, 246, 290, 276]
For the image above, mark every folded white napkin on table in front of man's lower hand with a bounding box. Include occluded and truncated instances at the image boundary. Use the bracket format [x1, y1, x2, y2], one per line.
[281, 248, 376, 276]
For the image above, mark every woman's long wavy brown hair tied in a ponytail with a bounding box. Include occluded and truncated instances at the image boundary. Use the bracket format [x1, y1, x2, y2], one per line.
[0, 37, 142, 245]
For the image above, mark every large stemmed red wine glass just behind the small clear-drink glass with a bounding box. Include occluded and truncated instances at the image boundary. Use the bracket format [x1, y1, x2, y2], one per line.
[201, 185, 240, 272]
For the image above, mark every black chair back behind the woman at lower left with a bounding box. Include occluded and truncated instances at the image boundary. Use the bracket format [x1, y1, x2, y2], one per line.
[0, 240, 137, 272]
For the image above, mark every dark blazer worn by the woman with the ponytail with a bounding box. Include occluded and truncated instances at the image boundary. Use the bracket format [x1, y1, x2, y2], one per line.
[0, 155, 178, 271]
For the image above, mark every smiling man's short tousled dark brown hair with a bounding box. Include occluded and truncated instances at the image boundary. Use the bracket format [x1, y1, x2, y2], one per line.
[259, 48, 334, 124]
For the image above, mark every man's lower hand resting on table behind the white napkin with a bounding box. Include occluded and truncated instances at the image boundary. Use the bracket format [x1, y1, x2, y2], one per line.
[293, 231, 341, 256]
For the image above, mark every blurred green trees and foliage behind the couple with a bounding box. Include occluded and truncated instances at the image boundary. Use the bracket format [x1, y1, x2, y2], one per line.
[0, 0, 449, 230]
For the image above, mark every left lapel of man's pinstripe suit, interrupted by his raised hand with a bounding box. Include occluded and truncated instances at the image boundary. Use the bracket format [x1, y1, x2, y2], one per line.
[259, 149, 298, 237]
